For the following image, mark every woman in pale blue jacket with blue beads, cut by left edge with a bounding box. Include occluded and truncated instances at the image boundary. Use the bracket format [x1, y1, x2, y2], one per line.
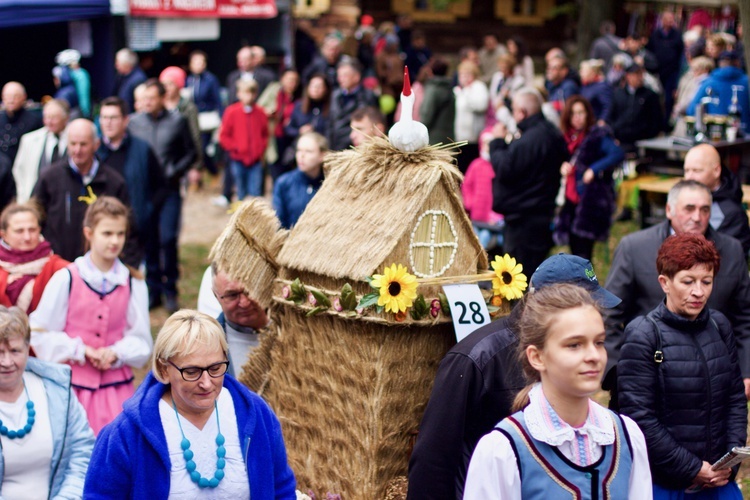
[0, 306, 94, 500]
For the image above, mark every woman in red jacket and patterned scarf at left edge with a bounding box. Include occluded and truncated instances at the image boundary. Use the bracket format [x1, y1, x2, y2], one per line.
[0, 203, 68, 314]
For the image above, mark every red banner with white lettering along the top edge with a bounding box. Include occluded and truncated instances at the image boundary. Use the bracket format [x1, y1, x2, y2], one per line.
[130, 0, 278, 19]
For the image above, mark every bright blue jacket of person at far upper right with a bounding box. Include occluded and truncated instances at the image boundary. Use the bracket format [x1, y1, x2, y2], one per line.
[687, 66, 750, 131]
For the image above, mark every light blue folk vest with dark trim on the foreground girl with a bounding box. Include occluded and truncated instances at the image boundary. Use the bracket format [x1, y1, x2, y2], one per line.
[495, 412, 633, 500]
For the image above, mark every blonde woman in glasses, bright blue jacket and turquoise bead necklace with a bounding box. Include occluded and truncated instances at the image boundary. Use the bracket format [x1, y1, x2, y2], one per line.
[84, 309, 295, 499]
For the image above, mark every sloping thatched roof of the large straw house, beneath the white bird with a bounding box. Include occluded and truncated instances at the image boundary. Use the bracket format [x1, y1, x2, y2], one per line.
[278, 137, 483, 280]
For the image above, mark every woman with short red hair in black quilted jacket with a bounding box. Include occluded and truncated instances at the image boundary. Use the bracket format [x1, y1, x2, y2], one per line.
[617, 233, 747, 500]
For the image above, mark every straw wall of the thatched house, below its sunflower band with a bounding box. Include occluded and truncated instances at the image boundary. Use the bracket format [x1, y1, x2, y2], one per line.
[264, 306, 455, 500]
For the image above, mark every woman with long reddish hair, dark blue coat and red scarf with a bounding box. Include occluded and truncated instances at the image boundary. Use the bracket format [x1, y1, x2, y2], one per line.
[554, 95, 625, 260]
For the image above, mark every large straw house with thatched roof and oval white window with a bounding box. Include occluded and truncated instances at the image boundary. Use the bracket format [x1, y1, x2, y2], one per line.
[264, 138, 488, 500]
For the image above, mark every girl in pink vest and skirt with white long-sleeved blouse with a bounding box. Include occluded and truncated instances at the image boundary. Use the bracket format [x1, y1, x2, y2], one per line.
[30, 196, 153, 434]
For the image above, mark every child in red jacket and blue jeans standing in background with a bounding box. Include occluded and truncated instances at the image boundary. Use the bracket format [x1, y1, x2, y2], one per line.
[219, 80, 268, 201]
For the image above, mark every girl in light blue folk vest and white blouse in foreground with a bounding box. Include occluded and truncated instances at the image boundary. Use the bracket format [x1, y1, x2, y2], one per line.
[464, 284, 652, 500]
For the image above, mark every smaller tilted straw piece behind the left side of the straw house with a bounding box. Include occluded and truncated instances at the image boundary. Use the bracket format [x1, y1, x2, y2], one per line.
[209, 198, 289, 308]
